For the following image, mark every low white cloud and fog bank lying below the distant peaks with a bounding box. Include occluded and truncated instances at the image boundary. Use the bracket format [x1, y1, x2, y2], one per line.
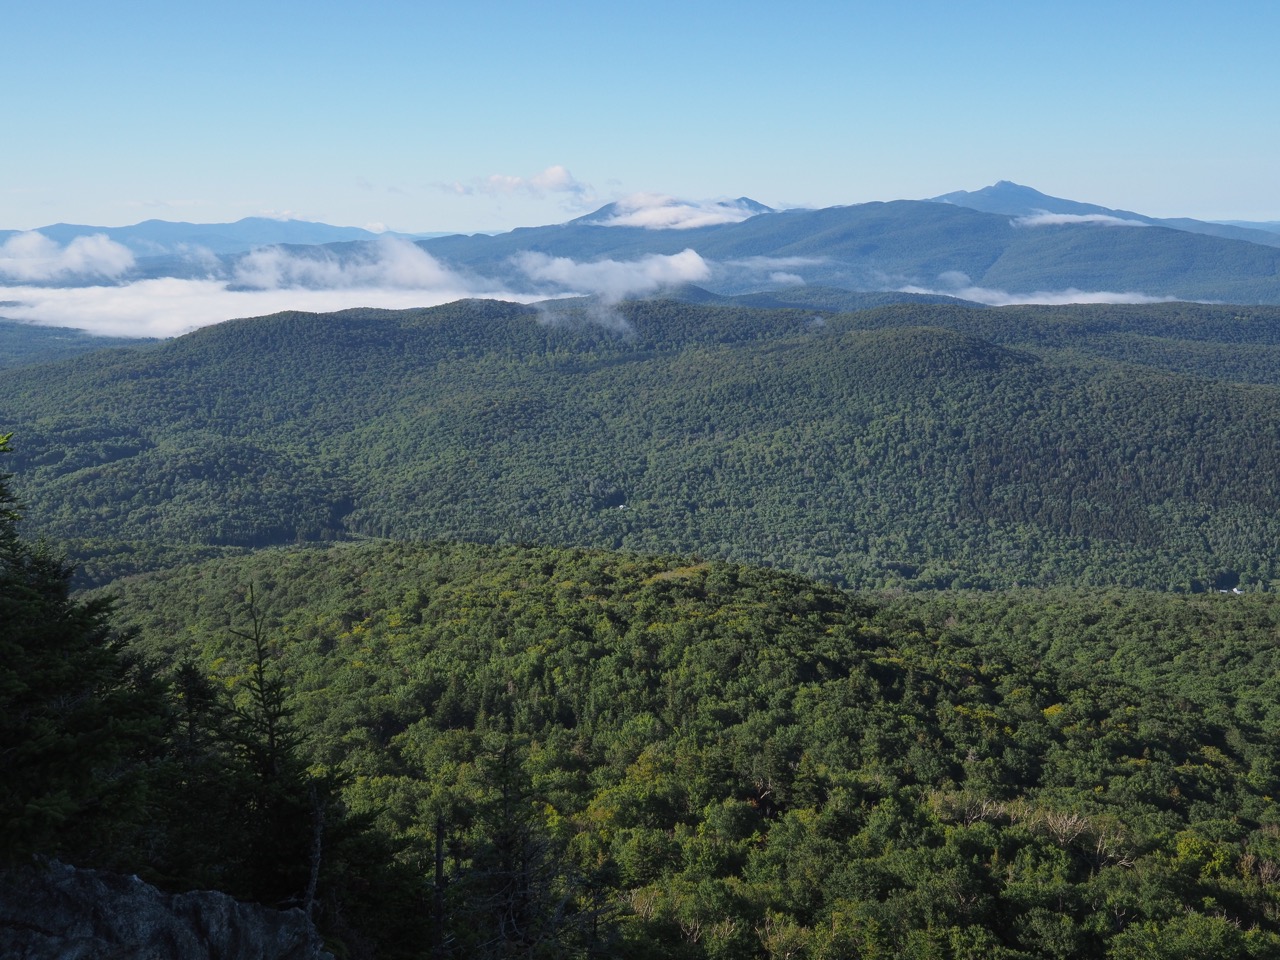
[0, 233, 1176, 337]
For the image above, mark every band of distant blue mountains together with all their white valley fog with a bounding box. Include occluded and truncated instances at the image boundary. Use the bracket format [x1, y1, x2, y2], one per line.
[0, 184, 1280, 337]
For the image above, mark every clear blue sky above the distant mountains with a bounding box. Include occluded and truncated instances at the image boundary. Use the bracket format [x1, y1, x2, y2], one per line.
[0, 0, 1280, 232]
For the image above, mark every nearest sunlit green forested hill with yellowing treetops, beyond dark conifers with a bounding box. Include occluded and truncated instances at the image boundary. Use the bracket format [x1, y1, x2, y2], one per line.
[90, 544, 1280, 960]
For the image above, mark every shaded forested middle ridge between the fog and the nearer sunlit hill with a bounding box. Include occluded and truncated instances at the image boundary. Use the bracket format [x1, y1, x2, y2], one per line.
[0, 301, 1280, 590]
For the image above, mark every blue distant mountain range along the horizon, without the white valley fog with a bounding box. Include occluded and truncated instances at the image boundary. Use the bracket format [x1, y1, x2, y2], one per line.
[0, 180, 1280, 303]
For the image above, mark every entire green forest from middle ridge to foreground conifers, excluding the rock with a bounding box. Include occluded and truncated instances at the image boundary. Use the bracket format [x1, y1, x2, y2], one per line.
[0, 301, 1280, 960]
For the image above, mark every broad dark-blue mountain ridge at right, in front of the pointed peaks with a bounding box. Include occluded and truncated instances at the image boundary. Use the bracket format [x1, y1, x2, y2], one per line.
[419, 191, 1280, 303]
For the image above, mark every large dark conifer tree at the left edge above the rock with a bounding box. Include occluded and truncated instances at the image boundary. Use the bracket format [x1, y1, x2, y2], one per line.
[0, 435, 161, 863]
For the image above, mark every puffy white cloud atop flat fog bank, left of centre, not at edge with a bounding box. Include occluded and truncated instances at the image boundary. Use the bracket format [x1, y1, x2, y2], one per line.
[233, 237, 466, 289]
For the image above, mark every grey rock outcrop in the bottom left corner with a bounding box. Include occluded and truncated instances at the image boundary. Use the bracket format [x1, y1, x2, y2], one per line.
[0, 863, 332, 960]
